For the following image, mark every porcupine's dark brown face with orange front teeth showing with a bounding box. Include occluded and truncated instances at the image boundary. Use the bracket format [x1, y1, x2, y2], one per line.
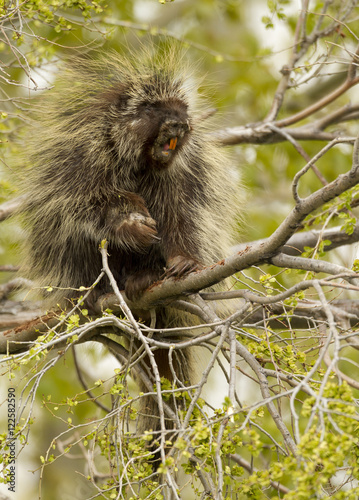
[138, 99, 191, 170]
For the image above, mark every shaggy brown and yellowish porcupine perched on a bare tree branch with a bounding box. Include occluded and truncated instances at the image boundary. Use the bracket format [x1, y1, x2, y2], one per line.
[18, 48, 237, 458]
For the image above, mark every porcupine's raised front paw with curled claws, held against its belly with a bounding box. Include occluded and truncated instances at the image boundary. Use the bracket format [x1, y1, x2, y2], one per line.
[116, 212, 160, 251]
